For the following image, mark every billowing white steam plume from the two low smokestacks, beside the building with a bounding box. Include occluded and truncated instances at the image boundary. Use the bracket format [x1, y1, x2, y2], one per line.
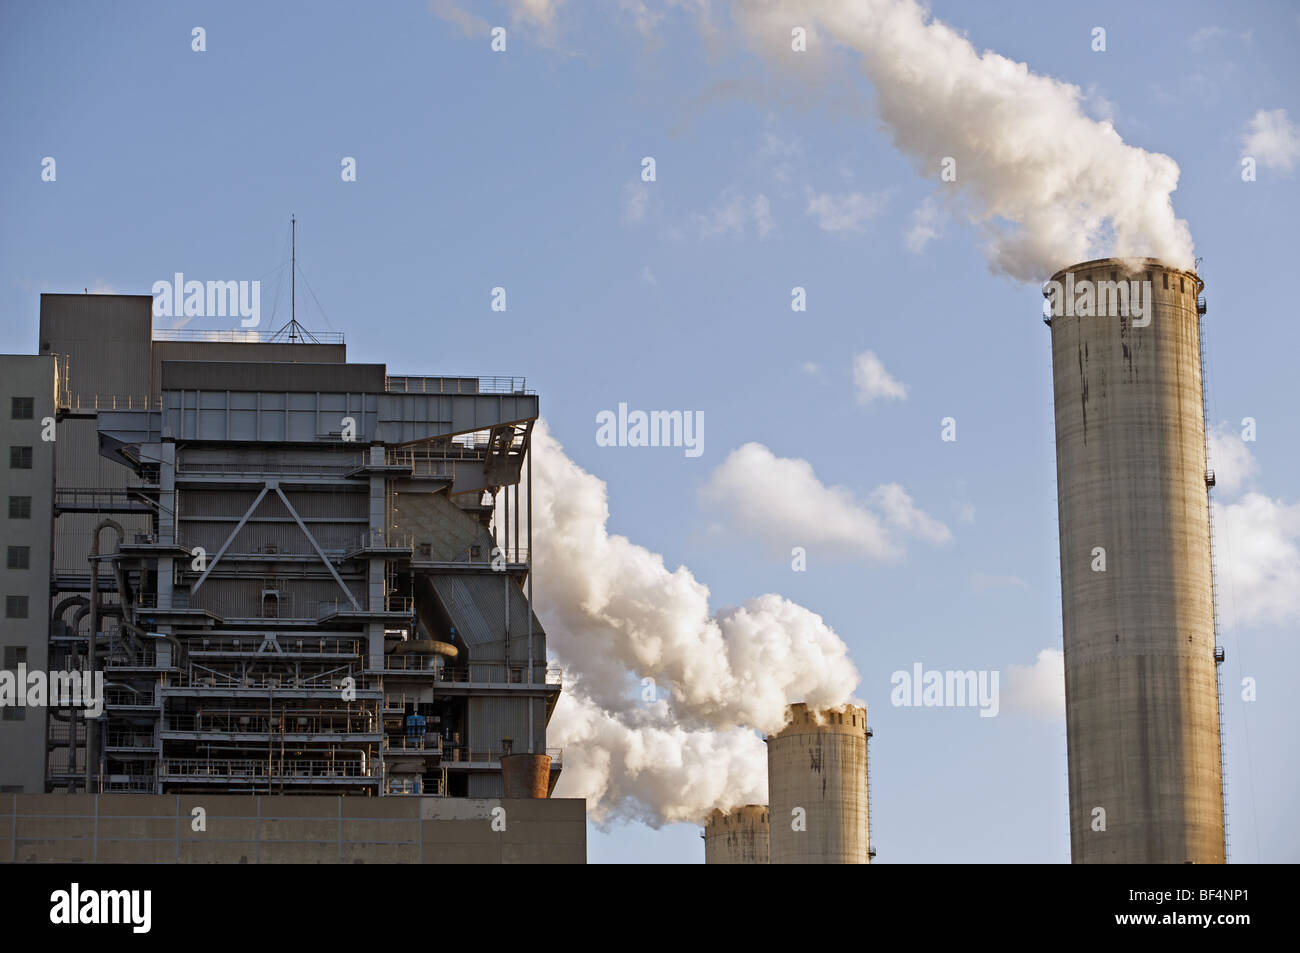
[514, 421, 859, 826]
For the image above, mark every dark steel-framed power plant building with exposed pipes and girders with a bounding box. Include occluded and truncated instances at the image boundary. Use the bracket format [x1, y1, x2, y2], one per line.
[0, 294, 585, 850]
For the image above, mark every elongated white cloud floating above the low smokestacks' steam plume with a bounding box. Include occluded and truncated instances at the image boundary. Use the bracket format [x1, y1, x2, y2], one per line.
[701, 443, 950, 560]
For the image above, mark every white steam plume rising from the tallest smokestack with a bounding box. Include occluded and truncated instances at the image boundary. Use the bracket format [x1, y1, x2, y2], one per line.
[732, 0, 1193, 281]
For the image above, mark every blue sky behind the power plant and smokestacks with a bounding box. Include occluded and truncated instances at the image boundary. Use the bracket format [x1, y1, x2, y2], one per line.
[0, 1, 1300, 862]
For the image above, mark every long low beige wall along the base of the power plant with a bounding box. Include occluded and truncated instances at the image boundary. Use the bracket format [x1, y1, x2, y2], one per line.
[0, 794, 586, 863]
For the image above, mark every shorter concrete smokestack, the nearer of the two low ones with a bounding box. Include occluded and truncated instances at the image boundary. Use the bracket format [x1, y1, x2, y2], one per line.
[767, 705, 870, 863]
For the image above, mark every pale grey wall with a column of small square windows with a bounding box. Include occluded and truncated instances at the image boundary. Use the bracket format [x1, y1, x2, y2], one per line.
[0, 355, 57, 792]
